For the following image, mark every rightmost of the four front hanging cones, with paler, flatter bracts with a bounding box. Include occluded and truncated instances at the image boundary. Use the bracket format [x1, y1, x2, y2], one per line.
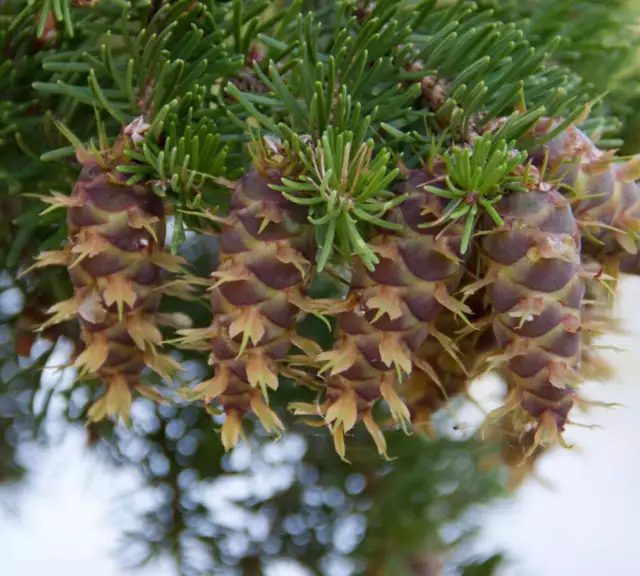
[482, 181, 585, 451]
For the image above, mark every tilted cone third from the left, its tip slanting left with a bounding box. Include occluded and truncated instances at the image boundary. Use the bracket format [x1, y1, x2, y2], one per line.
[296, 170, 470, 457]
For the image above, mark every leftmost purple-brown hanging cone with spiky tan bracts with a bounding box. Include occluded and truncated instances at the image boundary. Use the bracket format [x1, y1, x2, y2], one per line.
[25, 125, 182, 421]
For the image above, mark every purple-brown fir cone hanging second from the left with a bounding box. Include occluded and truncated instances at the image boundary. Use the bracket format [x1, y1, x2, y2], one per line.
[181, 144, 319, 449]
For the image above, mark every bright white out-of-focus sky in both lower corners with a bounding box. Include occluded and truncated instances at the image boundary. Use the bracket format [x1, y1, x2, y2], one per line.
[0, 279, 640, 576]
